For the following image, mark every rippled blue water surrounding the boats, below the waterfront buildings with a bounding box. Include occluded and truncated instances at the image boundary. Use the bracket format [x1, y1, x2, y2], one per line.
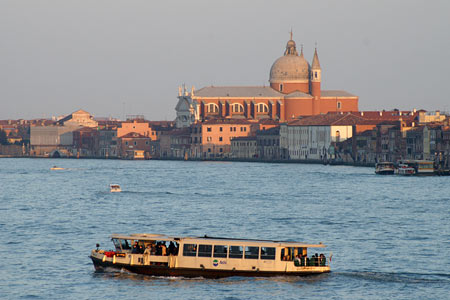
[0, 159, 450, 299]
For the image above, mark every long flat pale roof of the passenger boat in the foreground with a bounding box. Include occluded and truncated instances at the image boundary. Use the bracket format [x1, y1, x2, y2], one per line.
[111, 233, 326, 248]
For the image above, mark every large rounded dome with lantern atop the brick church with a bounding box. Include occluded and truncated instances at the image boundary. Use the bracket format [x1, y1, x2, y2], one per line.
[269, 40, 310, 83]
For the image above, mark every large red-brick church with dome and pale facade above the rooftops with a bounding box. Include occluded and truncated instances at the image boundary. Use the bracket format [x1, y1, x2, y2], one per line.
[176, 35, 358, 127]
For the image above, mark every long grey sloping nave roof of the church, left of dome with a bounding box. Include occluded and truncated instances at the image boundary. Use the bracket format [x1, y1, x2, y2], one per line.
[193, 86, 284, 98]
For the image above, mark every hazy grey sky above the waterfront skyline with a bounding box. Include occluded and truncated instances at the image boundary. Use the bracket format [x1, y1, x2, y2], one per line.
[0, 0, 450, 120]
